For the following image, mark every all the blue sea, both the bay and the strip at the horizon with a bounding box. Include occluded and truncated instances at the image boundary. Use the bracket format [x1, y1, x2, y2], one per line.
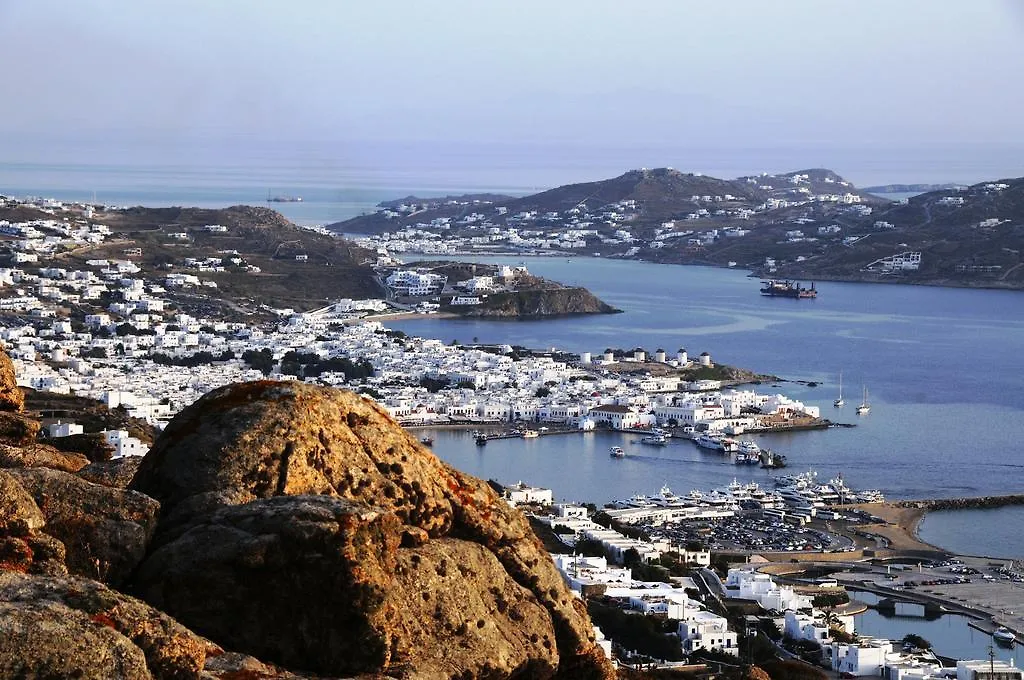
[0, 150, 1024, 557]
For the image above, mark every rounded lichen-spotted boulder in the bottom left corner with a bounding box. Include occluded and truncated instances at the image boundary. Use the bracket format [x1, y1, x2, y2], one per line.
[0, 572, 210, 680]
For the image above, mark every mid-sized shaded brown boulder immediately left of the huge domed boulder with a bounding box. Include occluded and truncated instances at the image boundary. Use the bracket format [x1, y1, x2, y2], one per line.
[7, 468, 160, 585]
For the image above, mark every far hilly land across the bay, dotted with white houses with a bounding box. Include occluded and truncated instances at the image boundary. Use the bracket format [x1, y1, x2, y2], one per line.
[328, 168, 1024, 289]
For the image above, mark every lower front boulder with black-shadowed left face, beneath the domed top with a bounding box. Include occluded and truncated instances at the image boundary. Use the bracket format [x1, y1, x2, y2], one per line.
[134, 496, 558, 678]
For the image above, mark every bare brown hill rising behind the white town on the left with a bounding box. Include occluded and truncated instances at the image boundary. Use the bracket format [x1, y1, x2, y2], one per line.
[59, 206, 384, 321]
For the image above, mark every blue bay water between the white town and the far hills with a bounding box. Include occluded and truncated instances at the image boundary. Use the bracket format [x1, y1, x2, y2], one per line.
[390, 257, 1024, 520]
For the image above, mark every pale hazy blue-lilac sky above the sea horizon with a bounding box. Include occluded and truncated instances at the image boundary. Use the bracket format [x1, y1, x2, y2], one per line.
[0, 0, 1024, 186]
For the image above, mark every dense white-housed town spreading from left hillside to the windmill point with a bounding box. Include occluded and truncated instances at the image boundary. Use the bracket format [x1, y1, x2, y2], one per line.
[0, 192, 819, 453]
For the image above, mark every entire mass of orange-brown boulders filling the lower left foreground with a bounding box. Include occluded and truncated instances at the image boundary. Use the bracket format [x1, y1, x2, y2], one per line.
[0, 353, 613, 680]
